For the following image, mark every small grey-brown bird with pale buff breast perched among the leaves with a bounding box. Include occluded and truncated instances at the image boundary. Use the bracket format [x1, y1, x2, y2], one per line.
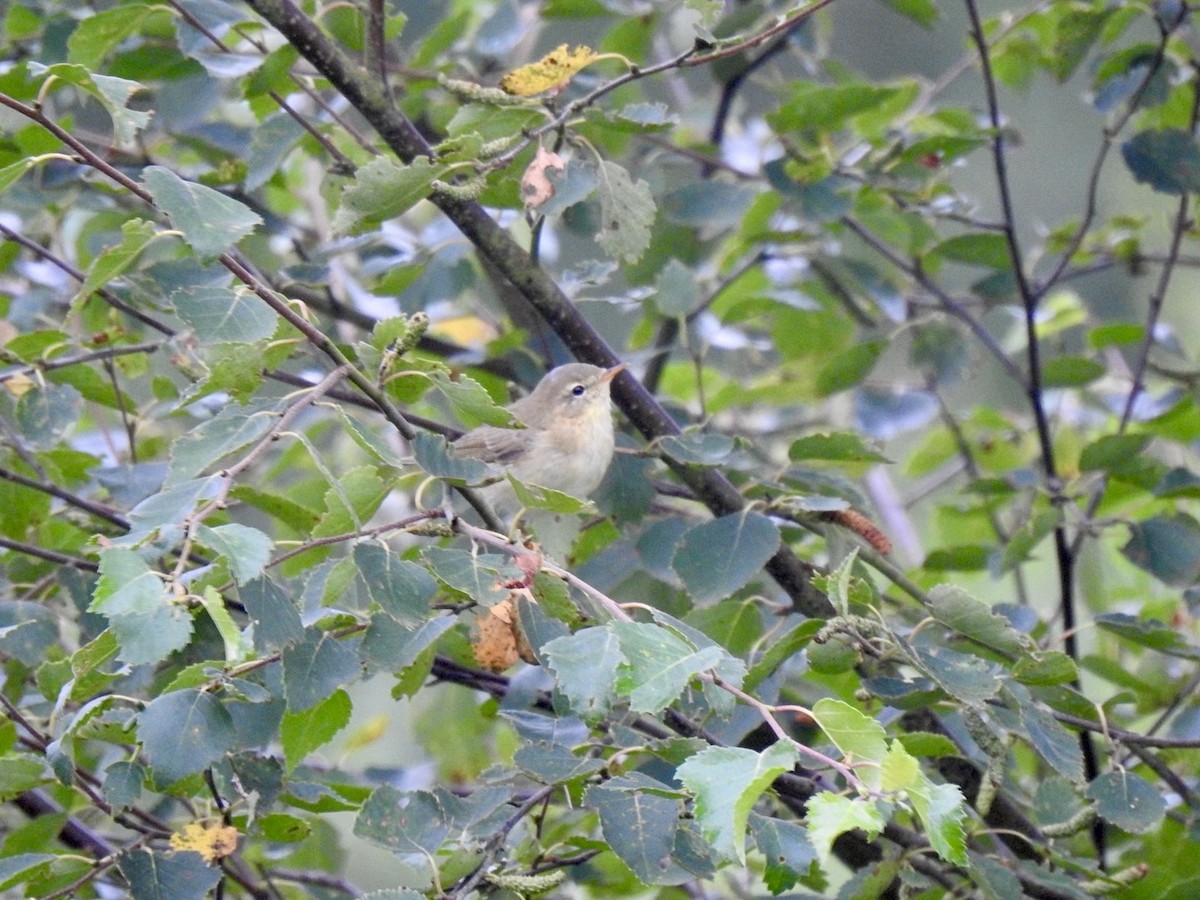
[454, 362, 625, 516]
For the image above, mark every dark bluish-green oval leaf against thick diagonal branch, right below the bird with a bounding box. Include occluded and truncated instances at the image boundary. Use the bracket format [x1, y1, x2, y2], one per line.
[671, 511, 779, 605]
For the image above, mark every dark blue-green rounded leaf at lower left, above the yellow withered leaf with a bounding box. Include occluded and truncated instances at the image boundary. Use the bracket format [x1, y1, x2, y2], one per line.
[137, 689, 236, 785]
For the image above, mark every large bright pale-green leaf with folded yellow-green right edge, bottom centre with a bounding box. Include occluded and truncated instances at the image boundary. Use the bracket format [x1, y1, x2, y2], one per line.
[676, 740, 799, 865]
